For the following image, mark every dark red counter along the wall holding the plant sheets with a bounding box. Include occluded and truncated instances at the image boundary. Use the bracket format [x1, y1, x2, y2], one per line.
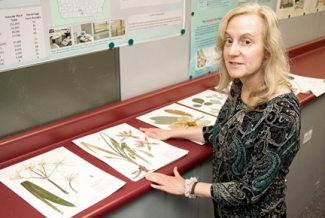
[0, 36, 325, 217]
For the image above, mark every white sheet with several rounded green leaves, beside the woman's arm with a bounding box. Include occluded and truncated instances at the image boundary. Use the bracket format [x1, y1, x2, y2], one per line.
[177, 90, 227, 116]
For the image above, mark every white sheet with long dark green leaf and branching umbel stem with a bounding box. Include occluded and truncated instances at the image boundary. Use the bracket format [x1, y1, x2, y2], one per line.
[0, 147, 125, 218]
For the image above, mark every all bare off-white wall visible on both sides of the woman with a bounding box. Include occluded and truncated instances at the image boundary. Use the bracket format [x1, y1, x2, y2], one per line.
[120, 4, 325, 100]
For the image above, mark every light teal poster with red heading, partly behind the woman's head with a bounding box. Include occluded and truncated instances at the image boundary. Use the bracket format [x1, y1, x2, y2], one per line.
[189, 0, 274, 78]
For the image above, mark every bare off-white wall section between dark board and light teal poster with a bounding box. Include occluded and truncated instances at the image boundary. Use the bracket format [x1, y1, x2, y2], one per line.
[120, 1, 191, 100]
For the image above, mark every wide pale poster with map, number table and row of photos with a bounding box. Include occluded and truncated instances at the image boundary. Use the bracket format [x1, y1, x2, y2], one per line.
[0, 0, 185, 72]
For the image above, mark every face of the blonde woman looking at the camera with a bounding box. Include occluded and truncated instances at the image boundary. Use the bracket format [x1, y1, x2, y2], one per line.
[223, 14, 265, 83]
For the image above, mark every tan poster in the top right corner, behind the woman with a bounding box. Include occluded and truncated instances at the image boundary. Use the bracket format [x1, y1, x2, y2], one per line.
[276, 0, 325, 19]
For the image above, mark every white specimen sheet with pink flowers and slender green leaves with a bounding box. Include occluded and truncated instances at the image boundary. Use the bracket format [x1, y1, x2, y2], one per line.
[73, 123, 188, 182]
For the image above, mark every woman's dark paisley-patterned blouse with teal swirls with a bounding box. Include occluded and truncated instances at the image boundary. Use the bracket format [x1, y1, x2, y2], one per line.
[203, 80, 301, 218]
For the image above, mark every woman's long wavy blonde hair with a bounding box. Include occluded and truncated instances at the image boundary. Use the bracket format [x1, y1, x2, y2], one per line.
[216, 2, 291, 110]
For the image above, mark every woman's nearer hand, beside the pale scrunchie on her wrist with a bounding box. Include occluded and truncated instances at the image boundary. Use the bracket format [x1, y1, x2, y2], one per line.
[145, 167, 185, 195]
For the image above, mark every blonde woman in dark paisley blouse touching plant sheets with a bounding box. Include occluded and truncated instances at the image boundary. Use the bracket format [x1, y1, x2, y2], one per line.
[140, 3, 301, 217]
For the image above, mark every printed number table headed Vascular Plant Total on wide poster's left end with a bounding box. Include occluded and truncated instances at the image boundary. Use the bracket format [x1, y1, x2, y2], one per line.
[0, 7, 46, 69]
